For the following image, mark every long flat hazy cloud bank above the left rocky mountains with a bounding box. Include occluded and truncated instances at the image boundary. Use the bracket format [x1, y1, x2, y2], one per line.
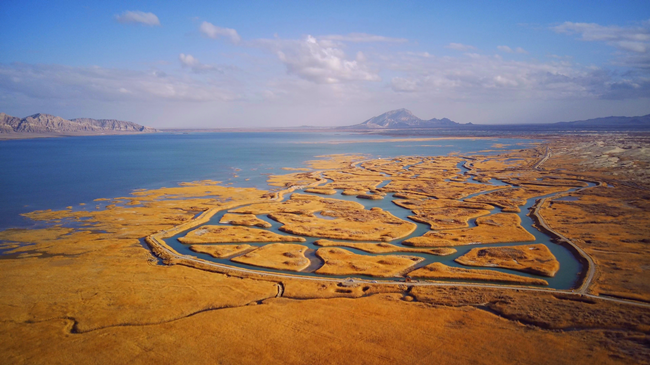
[0, 64, 239, 102]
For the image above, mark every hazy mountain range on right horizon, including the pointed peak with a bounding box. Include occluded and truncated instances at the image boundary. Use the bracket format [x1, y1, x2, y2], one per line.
[338, 109, 650, 131]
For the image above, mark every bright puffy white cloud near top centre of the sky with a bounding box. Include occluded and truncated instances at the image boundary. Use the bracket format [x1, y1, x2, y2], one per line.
[257, 36, 381, 84]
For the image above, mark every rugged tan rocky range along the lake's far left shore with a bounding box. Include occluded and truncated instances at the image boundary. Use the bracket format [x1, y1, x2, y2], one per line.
[0, 113, 158, 134]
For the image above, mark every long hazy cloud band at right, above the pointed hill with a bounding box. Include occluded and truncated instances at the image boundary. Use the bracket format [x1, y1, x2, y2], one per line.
[386, 50, 650, 101]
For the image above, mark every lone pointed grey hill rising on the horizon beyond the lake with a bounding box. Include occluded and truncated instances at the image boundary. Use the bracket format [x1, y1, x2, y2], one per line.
[341, 109, 460, 129]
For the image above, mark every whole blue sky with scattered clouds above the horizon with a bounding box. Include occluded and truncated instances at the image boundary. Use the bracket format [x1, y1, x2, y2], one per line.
[0, 0, 650, 128]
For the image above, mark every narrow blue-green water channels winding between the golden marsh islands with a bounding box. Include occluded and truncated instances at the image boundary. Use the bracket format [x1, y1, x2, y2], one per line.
[165, 161, 595, 289]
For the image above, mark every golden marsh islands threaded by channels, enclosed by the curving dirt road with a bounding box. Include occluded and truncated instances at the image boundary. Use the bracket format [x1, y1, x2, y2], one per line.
[158, 154, 595, 289]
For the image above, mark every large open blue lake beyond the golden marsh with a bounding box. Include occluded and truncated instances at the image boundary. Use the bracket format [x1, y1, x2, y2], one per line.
[0, 132, 530, 229]
